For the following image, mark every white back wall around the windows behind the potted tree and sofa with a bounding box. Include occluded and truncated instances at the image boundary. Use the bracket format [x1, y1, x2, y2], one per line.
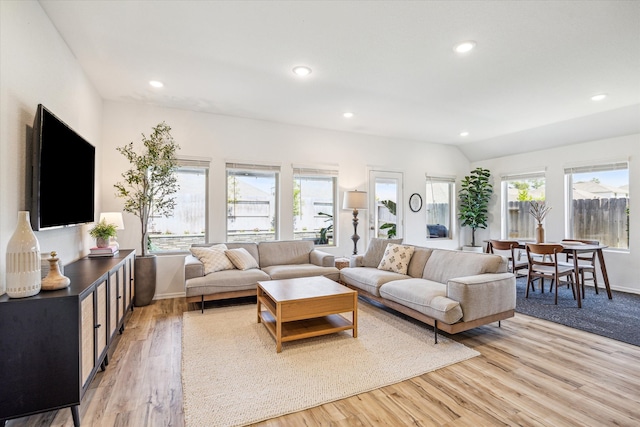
[101, 102, 469, 297]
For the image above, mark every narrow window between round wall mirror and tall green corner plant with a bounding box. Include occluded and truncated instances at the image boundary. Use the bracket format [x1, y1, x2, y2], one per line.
[424, 176, 455, 239]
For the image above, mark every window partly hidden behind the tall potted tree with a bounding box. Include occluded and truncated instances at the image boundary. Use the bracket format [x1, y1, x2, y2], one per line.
[149, 159, 209, 252]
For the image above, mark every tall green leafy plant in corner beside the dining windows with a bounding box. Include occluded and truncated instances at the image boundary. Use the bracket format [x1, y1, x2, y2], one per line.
[458, 167, 493, 246]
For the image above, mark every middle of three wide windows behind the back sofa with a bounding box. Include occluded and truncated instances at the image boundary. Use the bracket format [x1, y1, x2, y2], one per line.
[227, 163, 280, 242]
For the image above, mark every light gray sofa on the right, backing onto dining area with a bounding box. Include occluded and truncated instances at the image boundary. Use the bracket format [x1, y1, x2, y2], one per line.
[340, 239, 516, 342]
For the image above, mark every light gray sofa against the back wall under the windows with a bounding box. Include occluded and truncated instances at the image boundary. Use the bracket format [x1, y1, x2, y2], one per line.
[184, 240, 340, 309]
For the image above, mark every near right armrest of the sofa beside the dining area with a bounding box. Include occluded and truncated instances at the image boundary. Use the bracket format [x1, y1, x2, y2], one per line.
[447, 273, 516, 322]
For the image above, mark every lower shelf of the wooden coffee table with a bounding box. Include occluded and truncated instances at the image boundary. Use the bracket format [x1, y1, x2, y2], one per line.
[260, 310, 353, 342]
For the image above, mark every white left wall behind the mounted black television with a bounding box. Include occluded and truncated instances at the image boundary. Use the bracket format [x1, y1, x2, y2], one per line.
[0, 1, 102, 294]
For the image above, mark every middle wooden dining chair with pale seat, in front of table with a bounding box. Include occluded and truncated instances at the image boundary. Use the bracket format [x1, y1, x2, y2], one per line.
[525, 243, 576, 304]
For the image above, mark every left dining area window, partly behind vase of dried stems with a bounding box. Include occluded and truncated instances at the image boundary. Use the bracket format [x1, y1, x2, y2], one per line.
[502, 172, 545, 239]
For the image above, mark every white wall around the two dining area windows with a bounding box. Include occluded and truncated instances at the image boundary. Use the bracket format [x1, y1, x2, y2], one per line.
[472, 134, 640, 293]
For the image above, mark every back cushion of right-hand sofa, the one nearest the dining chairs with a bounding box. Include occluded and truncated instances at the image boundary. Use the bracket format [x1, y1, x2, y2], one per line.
[422, 249, 507, 284]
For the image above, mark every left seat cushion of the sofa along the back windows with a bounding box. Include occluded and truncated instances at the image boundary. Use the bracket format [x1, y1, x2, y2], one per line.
[185, 268, 269, 297]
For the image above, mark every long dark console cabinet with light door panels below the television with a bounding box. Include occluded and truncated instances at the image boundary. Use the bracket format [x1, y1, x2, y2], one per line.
[0, 250, 135, 426]
